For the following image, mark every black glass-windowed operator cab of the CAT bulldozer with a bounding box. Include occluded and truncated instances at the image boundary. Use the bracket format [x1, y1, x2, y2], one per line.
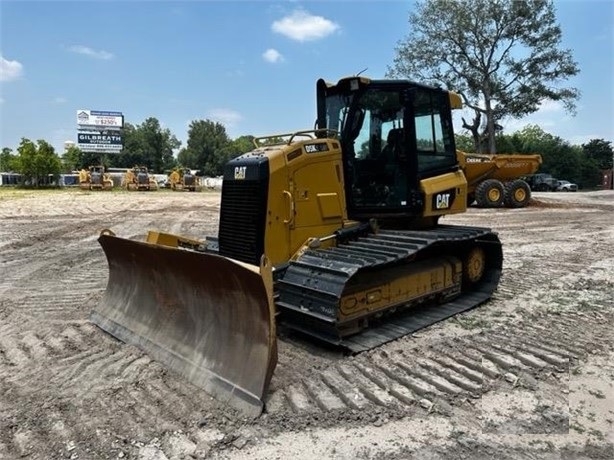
[317, 77, 460, 218]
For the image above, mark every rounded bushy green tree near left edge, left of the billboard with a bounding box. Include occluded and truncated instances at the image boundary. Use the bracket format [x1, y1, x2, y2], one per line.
[14, 138, 62, 187]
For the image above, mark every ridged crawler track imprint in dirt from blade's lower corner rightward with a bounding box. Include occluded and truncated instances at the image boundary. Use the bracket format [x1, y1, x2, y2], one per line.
[267, 314, 614, 420]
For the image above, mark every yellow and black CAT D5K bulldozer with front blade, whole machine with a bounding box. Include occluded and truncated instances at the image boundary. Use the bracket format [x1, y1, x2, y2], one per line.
[91, 77, 503, 417]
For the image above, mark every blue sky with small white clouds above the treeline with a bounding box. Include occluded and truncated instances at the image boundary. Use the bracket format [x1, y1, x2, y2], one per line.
[0, 0, 614, 152]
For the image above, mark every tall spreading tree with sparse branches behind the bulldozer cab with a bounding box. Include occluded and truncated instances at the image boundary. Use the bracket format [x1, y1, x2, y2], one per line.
[387, 0, 580, 153]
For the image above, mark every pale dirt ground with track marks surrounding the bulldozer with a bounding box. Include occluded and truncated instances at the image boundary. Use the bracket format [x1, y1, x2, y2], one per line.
[0, 189, 614, 460]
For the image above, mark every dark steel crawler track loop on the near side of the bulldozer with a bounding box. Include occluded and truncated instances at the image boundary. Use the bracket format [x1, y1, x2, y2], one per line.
[276, 225, 502, 353]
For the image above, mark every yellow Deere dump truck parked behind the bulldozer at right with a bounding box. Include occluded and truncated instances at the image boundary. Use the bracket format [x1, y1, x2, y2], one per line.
[457, 150, 542, 208]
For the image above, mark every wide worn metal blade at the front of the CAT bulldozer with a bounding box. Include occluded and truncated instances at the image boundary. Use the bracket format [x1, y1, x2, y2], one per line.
[90, 230, 277, 417]
